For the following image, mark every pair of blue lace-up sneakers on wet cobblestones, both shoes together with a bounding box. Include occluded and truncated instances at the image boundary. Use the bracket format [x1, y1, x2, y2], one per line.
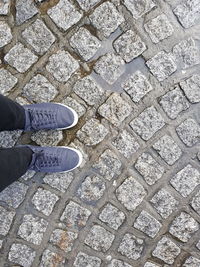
[20, 103, 82, 172]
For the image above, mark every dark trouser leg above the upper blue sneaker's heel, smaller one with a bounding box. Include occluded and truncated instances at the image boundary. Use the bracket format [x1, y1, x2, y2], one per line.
[0, 95, 25, 131]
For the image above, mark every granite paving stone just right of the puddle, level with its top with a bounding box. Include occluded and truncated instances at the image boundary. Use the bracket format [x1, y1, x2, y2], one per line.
[146, 51, 177, 82]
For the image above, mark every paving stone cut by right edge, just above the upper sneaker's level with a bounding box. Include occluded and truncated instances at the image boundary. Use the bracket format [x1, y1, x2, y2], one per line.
[180, 74, 200, 103]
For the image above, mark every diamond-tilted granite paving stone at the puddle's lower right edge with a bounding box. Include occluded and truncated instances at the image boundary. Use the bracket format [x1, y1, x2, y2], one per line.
[122, 71, 153, 103]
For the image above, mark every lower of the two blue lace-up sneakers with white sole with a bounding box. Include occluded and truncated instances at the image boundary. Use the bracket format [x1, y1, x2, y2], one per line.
[25, 145, 82, 173]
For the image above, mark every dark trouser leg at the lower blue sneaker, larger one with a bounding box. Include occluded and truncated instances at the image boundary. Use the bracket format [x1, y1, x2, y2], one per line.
[0, 147, 33, 192]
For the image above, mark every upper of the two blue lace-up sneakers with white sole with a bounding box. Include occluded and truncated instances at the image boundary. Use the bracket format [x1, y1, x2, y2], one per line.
[23, 103, 78, 131]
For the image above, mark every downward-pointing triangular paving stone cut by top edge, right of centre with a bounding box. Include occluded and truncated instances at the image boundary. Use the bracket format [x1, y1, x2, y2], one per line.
[124, 0, 156, 19]
